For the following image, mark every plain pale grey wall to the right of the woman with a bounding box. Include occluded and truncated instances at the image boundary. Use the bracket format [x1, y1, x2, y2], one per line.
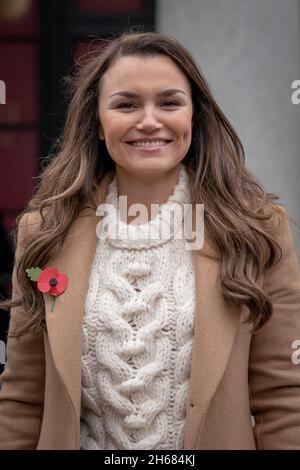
[156, 0, 300, 258]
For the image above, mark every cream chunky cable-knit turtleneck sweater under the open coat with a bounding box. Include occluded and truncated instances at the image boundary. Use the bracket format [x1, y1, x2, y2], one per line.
[80, 164, 195, 450]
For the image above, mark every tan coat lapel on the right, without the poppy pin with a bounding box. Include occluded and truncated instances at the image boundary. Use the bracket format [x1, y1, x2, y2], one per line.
[184, 250, 240, 449]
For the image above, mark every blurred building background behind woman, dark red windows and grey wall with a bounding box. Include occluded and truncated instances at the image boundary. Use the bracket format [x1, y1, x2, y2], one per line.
[0, 0, 300, 364]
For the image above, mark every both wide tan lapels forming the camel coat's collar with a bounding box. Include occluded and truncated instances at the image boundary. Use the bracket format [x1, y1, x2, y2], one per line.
[44, 172, 240, 449]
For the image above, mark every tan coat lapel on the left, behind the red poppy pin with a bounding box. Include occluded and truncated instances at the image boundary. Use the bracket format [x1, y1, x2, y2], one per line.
[43, 173, 113, 417]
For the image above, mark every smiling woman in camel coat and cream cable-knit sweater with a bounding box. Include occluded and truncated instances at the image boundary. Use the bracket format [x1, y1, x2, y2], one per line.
[0, 32, 300, 449]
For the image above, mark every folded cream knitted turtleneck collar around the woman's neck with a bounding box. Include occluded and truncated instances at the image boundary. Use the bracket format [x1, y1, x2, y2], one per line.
[100, 163, 191, 249]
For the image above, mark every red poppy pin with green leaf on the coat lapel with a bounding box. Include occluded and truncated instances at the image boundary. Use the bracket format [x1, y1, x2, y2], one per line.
[26, 266, 68, 312]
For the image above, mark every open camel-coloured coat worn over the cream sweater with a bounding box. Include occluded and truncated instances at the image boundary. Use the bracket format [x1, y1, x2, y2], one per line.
[0, 174, 300, 450]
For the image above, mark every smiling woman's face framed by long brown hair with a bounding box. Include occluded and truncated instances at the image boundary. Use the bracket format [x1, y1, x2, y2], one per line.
[99, 55, 193, 175]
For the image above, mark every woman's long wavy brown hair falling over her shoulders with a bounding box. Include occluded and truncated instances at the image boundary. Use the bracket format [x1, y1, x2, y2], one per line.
[0, 32, 282, 336]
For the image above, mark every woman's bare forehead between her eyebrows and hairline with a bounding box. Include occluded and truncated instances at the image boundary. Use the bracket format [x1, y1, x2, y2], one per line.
[101, 55, 190, 95]
